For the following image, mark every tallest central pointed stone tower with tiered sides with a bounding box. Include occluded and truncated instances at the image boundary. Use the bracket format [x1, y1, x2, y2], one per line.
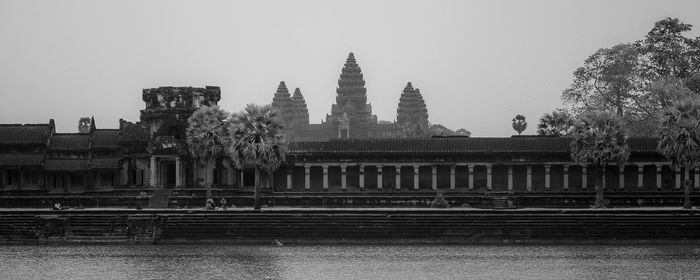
[326, 53, 377, 138]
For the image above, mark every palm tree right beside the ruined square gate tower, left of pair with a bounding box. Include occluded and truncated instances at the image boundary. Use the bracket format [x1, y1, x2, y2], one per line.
[186, 106, 228, 198]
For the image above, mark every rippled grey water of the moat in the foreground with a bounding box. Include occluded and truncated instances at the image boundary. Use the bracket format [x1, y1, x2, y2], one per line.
[0, 245, 700, 280]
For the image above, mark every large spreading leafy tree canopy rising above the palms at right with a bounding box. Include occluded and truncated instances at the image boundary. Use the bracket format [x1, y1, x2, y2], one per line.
[562, 18, 700, 135]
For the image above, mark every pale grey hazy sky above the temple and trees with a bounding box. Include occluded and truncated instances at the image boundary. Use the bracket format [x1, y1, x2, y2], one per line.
[0, 0, 700, 137]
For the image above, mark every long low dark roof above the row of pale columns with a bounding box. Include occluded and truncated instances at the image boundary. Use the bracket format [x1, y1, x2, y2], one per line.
[289, 137, 657, 154]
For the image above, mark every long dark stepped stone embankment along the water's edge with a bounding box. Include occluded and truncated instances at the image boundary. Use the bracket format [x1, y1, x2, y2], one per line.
[0, 208, 700, 244]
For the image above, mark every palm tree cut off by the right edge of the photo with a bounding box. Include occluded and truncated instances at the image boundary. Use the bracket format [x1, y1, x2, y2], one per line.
[658, 99, 700, 209]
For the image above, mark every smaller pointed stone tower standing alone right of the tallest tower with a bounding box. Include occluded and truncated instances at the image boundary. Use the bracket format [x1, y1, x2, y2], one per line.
[396, 82, 428, 126]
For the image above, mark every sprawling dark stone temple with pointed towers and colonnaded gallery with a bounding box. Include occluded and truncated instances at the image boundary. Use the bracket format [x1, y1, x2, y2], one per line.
[0, 53, 700, 206]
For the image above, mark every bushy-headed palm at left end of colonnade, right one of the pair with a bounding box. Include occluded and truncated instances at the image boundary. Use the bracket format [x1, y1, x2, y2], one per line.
[227, 104, 287, 209]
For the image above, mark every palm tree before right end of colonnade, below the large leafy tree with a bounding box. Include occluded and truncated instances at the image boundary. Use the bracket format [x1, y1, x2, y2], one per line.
[571, 112, 630, 208]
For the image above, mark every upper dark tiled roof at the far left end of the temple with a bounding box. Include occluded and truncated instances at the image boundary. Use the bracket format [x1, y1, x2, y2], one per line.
[0, 124, 51, 146]
